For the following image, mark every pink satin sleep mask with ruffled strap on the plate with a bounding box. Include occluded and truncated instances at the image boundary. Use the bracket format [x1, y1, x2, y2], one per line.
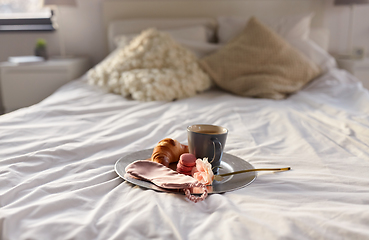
[125, 160, 208, 202]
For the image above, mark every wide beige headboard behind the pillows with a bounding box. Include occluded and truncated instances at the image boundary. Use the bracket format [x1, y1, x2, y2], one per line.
[102, 0, 324, 50]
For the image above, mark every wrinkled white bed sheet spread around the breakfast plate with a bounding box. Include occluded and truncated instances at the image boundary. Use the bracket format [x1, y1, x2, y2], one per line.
[0, 69, 369, 240]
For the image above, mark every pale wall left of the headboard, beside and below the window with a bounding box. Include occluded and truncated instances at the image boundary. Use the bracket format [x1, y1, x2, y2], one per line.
[0, 0, 106, 64]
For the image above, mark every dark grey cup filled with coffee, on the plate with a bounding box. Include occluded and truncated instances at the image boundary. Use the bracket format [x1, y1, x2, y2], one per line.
[187, 124, 228, 174]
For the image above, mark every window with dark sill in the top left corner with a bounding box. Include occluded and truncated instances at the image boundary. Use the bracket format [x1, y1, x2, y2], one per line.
[0, 0, 55, 32]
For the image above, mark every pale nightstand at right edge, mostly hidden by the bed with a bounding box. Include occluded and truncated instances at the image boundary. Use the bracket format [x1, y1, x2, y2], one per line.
[336, 58, 369, 89]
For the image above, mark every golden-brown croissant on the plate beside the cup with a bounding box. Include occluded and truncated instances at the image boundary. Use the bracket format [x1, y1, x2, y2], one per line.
[150, 138, 188, 167]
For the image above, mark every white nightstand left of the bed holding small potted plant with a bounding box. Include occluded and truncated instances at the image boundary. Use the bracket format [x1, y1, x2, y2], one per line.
[0, 57, 91, 113]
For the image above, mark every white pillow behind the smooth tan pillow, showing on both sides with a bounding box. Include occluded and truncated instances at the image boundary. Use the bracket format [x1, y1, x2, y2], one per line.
[217, 14, 337, 72]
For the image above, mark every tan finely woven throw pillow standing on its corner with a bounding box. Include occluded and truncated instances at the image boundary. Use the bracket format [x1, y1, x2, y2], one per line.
[200, 17, 320, 99]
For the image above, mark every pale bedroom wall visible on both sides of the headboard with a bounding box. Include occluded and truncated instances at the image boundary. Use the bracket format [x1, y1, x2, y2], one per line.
[0, 0, 369, 64]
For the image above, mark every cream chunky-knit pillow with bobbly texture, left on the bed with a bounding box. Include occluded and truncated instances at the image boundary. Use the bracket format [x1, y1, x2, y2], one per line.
[88, 29, 211, 101]
